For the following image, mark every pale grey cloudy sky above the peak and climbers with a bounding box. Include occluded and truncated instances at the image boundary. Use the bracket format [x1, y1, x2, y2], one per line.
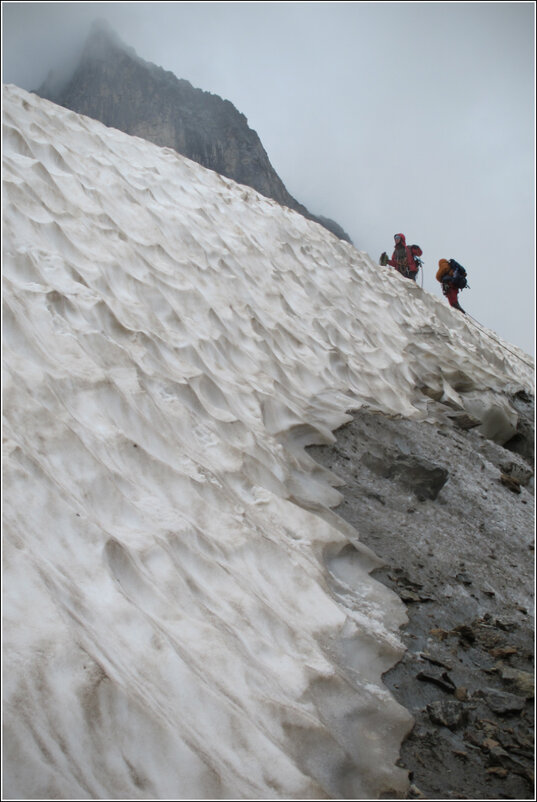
[2, 2, 535, 354]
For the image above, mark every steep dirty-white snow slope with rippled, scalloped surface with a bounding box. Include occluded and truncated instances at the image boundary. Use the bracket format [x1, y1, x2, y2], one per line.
[3, 86, 533, 799]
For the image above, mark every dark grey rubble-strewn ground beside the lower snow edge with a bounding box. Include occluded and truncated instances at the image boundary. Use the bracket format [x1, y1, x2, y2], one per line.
[308, 406, 535, 799]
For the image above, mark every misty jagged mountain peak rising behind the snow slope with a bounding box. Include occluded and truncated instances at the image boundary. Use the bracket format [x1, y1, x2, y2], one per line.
[35, 23, 351, 242]
